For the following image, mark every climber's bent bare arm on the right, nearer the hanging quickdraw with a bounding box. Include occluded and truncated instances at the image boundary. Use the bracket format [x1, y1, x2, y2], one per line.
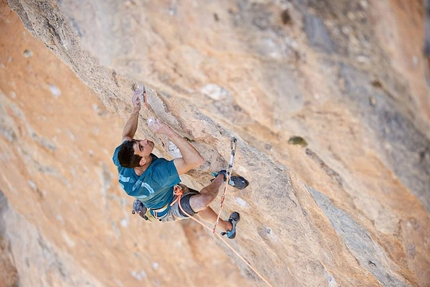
[149, 120, 204, 175]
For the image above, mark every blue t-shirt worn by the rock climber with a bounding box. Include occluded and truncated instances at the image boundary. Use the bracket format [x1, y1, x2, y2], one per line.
[112, 146, 181, 217]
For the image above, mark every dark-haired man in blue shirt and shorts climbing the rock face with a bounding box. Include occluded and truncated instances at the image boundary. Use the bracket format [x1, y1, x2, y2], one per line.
[112, 88, 248, 239]
